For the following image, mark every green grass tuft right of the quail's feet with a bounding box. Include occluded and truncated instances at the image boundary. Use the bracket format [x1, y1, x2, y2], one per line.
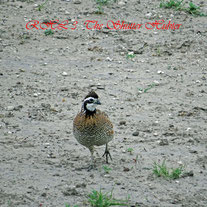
[153, 160, 183, 179]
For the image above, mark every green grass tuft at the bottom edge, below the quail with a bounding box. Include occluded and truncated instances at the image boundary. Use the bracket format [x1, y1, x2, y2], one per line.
[88, 189, 129, 207]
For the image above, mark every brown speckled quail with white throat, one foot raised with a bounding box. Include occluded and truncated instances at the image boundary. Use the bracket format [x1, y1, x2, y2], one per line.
[73, 91, 114, 168]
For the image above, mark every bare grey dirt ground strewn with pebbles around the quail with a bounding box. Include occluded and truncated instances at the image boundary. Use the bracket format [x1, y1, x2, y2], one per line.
[0, 0, 207, 207]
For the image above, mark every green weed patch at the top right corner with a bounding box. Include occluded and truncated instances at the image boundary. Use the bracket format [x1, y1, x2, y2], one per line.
[160, 0, 207, 16]
